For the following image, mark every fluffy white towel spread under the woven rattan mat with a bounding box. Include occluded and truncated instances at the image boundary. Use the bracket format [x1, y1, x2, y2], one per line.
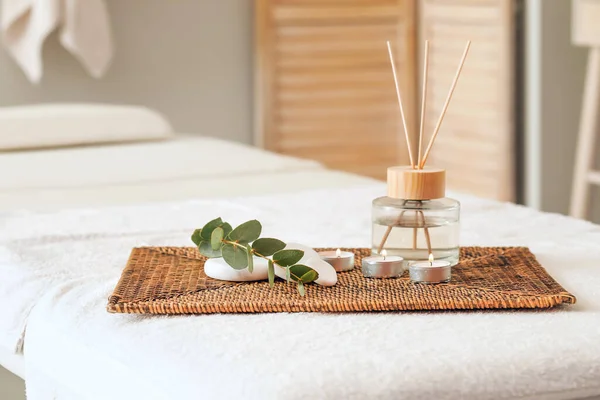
[0, 185, 600, 400]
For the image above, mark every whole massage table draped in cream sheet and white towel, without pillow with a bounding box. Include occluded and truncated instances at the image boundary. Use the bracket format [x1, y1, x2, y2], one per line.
[0, 104, 600, 400]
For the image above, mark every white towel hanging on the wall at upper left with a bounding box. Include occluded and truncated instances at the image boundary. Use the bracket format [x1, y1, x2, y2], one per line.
[1, 0, 113, 83]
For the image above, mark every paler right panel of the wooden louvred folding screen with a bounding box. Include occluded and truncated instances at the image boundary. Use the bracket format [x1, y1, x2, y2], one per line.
[418, 0, 515, 200]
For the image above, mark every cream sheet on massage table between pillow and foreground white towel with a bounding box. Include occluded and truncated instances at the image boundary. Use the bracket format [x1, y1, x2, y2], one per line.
[0, 136, 374, 210]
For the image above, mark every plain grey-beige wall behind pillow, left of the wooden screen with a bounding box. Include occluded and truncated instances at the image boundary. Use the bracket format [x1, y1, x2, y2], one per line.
[0, 0, 253, 142]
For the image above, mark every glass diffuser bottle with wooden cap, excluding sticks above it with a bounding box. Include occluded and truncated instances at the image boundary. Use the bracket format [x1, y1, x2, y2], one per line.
[371, 166, 460, 265]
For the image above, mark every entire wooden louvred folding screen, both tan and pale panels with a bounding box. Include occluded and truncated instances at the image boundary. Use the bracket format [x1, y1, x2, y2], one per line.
[255, 0, 514, 200]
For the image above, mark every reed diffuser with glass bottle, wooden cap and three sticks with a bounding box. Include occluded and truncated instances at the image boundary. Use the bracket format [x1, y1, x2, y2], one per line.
[371, 40, 471, 265]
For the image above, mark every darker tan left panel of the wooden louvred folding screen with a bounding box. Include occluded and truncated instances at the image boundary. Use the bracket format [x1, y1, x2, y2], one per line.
[255, 0, 416, 178]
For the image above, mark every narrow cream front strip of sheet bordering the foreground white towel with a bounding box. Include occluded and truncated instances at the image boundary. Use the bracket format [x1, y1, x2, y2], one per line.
[0, 170, 376, 211]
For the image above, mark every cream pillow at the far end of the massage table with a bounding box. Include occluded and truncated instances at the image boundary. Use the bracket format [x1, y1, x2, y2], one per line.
[0, 103, 173, 151]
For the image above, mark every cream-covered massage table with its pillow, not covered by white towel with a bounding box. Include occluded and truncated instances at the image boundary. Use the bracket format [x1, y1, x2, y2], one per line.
[0, 104, 374, 400]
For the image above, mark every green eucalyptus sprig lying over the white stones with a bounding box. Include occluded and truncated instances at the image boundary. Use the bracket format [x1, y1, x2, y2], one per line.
[192, 217, 319, 296]
